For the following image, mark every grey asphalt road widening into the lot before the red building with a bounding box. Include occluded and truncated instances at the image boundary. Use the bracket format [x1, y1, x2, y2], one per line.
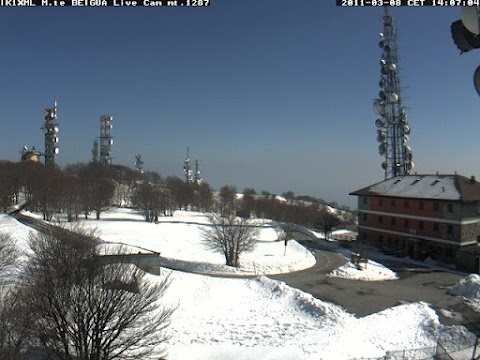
[269, 241, 480, 325]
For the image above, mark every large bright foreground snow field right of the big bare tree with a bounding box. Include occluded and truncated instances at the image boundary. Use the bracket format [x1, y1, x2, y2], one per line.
[157, 272, 459, 360]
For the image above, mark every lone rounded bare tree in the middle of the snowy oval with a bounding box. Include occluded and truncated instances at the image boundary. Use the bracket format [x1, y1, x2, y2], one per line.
[201, 214, 258, 267]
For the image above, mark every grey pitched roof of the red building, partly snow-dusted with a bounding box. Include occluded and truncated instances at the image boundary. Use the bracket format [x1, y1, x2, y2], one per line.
[350, 174, 480, 202]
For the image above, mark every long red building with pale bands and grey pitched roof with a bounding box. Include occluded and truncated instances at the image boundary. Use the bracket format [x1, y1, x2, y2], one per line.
[350, 174, 480, 272]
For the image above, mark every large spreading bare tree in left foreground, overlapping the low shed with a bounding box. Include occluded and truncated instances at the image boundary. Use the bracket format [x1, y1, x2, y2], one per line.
[21, 228, 172, 360]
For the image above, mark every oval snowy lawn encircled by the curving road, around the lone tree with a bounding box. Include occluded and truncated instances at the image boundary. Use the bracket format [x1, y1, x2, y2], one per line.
[77, 209, 315, 275]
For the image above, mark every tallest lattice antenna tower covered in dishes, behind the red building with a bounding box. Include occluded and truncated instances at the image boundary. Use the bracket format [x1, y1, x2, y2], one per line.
[373, 6, 414, 179]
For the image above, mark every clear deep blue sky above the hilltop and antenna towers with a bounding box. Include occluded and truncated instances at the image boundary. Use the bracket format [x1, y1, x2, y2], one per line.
[0, 0, 480, 205]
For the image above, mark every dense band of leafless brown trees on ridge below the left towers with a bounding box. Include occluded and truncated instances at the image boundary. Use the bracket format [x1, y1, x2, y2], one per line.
[0, 162, 213, 221]
